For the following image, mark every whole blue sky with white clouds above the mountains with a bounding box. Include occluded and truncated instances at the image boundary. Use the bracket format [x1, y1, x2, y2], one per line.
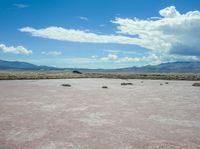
[0, 0, 200, 69]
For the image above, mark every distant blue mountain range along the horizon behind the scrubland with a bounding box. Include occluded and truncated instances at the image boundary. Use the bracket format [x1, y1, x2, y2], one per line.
[0, 60, 200, 73]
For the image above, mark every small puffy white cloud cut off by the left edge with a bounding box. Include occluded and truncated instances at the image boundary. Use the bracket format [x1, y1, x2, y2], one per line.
[0, 44, 32, 55]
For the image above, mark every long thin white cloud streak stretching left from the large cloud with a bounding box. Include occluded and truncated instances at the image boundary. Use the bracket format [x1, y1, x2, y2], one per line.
[19, 27, 137, 44]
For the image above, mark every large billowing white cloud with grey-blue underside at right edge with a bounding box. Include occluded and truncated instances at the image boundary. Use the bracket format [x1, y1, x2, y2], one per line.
[112, 6, 200, 55]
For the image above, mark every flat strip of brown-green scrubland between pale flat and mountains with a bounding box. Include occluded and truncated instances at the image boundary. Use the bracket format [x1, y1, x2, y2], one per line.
[0, 71, 200, 81]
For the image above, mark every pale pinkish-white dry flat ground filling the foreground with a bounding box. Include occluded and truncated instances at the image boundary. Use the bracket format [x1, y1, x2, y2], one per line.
[0, 79, 200, 149]
